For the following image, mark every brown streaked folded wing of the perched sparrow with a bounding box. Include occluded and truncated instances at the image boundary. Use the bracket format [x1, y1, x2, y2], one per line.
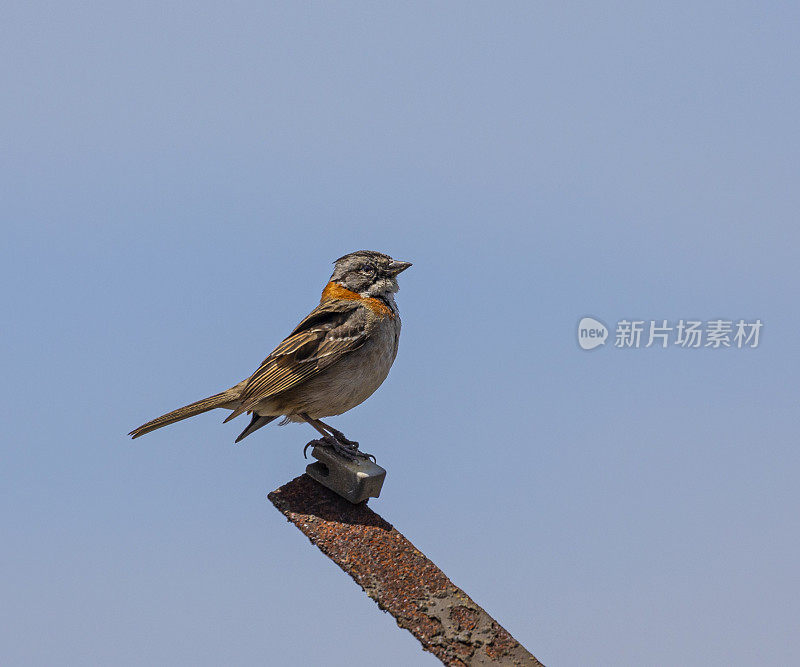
[225, 300, 367, 421]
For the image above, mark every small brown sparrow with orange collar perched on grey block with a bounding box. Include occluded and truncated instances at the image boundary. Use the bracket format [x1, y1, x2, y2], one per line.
[128, 250, 411, 460]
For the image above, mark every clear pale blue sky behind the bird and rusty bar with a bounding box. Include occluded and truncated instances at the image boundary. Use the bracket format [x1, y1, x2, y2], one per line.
[0, 2, 800, 666]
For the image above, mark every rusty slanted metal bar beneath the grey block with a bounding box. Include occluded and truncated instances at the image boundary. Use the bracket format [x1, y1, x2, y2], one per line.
[269, 475, 541, 665]
